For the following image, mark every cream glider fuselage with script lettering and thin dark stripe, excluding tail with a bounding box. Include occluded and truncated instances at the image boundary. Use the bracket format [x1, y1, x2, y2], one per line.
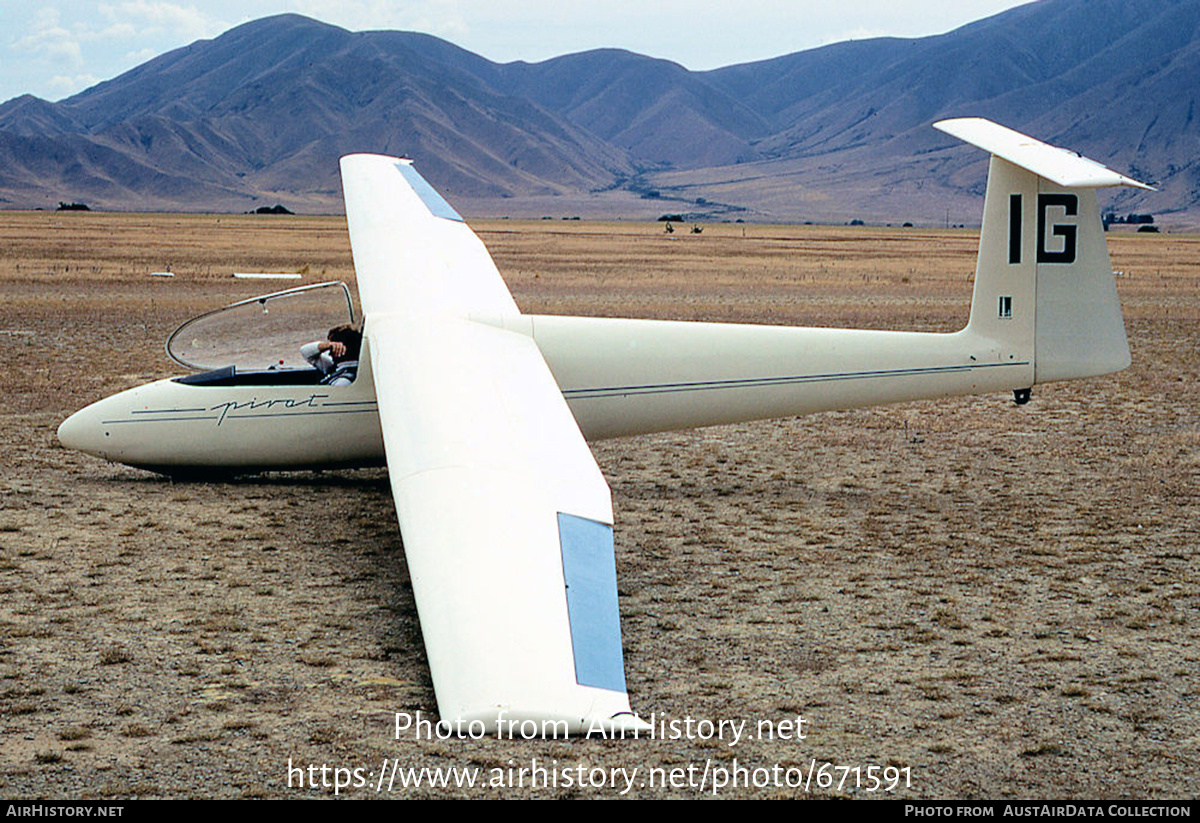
[59, 316, 1033, 474]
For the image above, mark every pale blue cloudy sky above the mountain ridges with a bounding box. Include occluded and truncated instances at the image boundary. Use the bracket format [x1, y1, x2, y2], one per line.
[0, 0, 1026, 101]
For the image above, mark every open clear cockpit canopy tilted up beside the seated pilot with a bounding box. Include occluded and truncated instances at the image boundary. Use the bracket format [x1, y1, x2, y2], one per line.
[167, 281, 354, 372]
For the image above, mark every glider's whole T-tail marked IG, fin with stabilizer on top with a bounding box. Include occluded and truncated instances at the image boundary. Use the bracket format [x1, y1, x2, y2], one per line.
[934, 118, 1151, 383]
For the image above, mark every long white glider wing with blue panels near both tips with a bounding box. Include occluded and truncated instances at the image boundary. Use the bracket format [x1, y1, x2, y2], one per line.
[342, 155, 636, 735]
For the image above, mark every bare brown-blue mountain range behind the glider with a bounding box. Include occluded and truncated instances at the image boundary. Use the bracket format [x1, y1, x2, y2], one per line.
[0, 0, 1200, 226]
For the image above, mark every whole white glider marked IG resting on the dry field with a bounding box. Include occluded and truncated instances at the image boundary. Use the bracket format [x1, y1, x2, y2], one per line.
[59, 119, 1146, 735]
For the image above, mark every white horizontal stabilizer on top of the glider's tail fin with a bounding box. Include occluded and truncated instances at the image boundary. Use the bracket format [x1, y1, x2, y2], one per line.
[934, 118, 1156, 192]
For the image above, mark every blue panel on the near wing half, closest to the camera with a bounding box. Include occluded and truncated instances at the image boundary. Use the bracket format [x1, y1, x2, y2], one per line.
[558, 513, 625, 692]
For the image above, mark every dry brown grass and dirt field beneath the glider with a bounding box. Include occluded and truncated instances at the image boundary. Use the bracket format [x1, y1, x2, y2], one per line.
[0, 212, 1200, 798]
